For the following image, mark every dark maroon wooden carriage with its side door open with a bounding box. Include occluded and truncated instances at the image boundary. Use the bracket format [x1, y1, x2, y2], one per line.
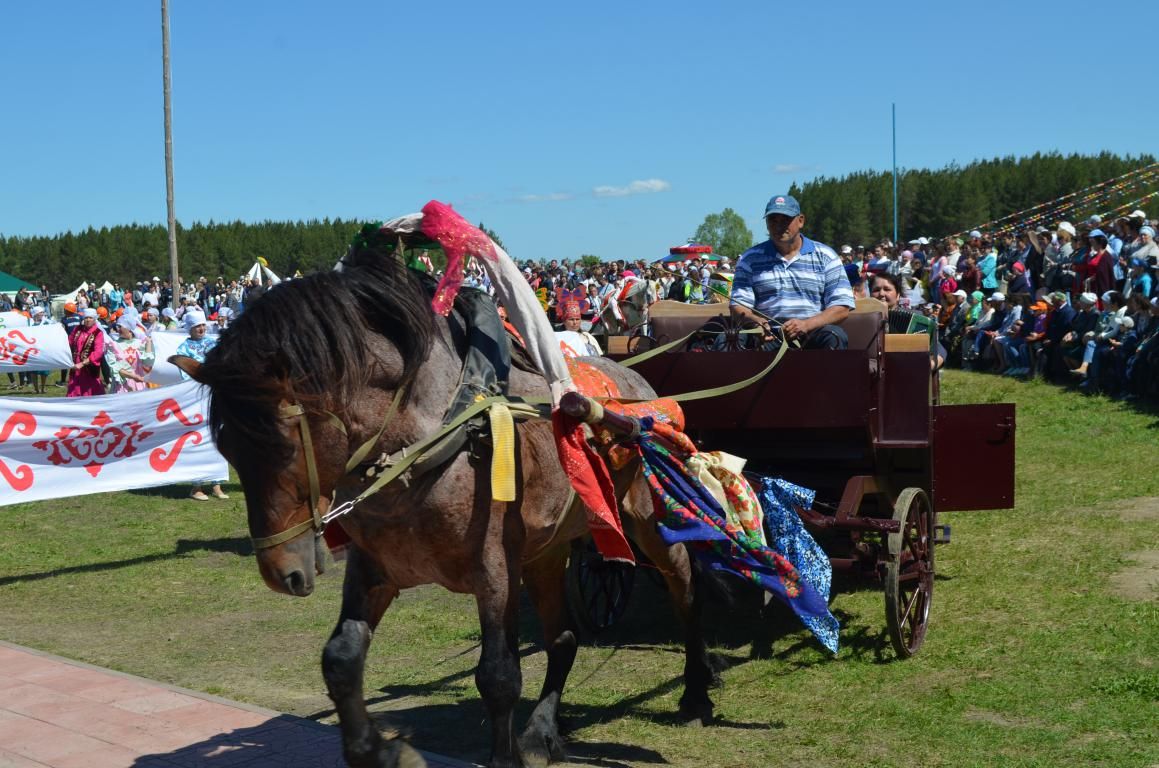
[570, 299, 1015, 657]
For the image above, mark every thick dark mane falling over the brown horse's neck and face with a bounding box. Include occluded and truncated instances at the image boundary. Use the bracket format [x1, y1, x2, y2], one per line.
[197, 237, 435, 455]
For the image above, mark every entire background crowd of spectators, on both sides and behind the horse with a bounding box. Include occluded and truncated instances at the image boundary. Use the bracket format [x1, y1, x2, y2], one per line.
[9, 211, 1159, 400]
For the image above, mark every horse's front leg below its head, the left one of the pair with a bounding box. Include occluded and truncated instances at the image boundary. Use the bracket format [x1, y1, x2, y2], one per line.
[322, 547, 427, 768]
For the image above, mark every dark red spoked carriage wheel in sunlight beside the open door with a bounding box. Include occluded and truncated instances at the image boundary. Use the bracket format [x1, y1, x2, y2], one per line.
[885, 488, 934, 659]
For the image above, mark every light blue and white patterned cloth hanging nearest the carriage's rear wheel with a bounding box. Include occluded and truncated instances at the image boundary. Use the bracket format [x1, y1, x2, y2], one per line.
[757, 476, 839, 653]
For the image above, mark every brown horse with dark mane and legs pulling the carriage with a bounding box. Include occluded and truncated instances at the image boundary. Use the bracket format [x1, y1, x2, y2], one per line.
[174, 238, 713, 767]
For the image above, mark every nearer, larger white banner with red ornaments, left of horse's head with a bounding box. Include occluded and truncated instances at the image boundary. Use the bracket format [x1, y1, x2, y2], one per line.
[0, 381, 229, 506]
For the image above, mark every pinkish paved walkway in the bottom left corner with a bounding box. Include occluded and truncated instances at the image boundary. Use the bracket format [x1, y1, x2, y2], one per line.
[0, 642, 469, 768]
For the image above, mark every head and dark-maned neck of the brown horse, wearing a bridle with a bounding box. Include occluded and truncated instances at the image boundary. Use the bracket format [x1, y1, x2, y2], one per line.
[172, 237, 433, 597]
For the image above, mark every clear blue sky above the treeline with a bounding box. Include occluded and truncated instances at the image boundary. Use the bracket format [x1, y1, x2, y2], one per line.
[0, 0, 1159, 268]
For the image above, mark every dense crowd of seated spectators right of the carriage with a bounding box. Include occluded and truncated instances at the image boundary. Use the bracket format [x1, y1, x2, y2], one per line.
[841, 211, 1159, 402]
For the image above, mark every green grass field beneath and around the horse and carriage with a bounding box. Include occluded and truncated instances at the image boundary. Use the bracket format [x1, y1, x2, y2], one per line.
[0, 372, 1159, 766]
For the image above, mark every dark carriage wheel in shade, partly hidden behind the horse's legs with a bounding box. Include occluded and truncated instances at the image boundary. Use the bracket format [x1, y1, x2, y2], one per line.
[567, 539, 636, 635]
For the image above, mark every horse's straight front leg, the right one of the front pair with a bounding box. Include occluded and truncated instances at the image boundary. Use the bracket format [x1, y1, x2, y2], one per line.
[475, 504, 524, 768]
